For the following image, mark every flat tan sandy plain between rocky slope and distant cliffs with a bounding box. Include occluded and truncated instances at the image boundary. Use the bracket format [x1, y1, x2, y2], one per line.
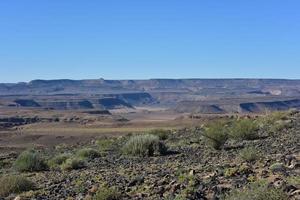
[0, 108, 201, 151]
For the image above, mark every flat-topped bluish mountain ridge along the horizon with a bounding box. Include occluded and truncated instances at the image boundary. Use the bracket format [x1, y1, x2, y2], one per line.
[0, 79, 300, 95]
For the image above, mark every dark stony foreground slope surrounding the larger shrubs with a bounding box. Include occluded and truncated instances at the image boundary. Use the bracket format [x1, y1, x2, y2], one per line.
[0, 112, 300, 200]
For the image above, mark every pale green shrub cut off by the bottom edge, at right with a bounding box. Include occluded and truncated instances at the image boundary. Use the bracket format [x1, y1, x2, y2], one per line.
[224, 182, 288, 200]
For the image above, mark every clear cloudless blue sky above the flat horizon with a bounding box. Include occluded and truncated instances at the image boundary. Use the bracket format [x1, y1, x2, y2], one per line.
[0, 0, 300, 82]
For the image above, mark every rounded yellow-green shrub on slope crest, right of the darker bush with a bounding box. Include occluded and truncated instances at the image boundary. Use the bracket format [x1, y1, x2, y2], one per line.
[229, 119, 259, 140]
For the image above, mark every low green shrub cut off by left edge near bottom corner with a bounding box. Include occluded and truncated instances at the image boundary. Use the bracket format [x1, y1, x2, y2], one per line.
[0, 175, 34, 197]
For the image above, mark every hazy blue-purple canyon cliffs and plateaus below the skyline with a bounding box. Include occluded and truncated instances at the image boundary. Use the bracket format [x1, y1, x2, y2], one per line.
[0, 79, 300, 113]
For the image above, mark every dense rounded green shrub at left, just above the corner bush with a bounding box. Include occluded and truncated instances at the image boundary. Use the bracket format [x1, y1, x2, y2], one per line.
[14, 150, 47, 172]
